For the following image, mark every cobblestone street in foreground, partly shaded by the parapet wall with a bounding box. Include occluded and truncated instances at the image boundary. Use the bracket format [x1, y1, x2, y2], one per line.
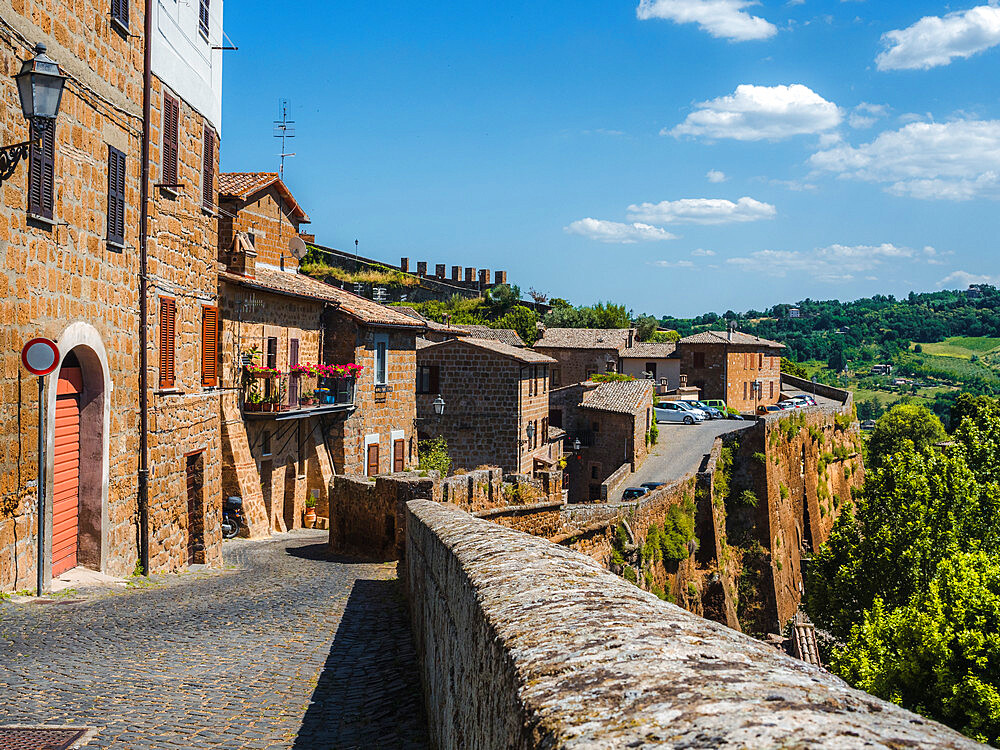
[0, 531, 427, 750]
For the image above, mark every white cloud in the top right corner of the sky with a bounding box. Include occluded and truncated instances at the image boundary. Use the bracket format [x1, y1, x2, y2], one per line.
[875, 3, 1000, 70]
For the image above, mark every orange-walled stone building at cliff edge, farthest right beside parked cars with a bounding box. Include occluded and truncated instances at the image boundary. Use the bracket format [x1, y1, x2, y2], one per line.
[677, 330, 785, 414]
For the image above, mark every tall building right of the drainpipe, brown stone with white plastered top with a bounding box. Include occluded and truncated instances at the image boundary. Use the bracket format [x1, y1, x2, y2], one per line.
[146, 2, 222, 571]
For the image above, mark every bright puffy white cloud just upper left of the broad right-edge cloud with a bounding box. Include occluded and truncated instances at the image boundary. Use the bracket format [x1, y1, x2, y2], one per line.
[660, 83, 843, 141]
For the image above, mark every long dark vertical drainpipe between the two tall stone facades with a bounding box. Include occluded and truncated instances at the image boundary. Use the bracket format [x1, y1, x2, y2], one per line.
[138, 0, 153, 576]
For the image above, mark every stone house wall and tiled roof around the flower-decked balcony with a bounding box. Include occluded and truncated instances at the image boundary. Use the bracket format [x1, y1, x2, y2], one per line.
[219, 281, 334, 537]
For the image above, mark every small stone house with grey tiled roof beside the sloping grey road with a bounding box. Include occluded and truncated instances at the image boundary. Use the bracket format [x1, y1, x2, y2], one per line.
[549, 380, 653, 503]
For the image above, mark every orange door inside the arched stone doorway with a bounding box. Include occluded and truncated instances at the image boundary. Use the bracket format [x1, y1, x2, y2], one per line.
[52, 367, 83, 576]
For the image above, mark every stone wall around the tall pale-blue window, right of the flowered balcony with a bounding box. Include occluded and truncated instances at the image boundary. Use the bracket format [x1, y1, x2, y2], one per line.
[323, 311, 418, 474]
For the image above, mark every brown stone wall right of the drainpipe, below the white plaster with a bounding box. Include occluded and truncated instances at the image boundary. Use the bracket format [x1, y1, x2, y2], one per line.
[147, 76, 222, 572]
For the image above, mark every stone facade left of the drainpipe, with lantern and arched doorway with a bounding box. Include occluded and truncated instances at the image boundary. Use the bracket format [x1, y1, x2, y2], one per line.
[0, 5, 143, 591]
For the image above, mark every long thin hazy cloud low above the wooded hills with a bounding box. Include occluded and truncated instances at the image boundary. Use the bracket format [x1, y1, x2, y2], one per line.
[726, 242, 915, 283]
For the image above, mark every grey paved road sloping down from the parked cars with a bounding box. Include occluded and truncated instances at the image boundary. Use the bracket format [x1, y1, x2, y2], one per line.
[609, 419, 753, 502]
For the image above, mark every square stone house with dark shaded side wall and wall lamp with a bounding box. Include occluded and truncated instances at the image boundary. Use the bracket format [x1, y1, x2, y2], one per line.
[416, 337, 562, 474]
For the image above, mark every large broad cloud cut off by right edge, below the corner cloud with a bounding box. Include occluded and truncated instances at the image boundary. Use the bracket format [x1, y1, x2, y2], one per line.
[809, 120, 1000, 200]
